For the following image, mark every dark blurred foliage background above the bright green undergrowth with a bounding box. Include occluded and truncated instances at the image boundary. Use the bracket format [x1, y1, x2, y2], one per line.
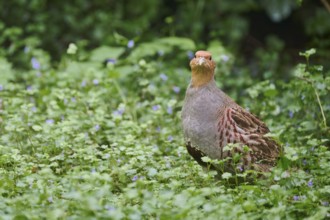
[0, 0, 330, 67]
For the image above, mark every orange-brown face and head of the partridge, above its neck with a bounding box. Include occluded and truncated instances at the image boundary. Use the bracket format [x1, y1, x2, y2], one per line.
[190, 50, 215, 73]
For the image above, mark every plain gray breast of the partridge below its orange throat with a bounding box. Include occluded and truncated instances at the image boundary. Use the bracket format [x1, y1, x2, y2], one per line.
[182, 81, 224, 159]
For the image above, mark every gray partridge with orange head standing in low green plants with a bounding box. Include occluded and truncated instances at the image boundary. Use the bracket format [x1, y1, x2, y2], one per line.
[182, 51, 280, 173]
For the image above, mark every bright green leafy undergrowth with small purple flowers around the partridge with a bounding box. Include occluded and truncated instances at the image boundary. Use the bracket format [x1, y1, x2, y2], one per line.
[0, 38, 330, 219]
